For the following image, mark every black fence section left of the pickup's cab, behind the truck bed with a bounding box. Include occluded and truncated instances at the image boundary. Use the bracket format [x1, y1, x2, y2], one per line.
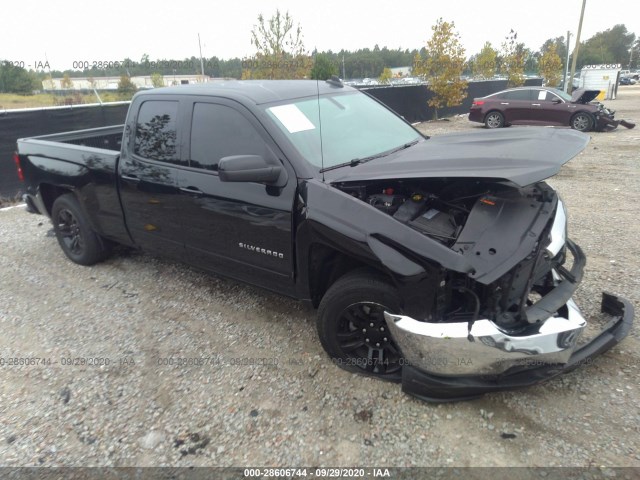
[0, 104, 129, 198]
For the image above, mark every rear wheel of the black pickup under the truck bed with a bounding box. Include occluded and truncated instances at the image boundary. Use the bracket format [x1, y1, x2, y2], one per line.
[51, 193, 110, 265]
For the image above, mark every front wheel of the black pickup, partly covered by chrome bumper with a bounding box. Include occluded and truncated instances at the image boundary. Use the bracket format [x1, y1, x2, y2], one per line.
[317, 270, 403, 381]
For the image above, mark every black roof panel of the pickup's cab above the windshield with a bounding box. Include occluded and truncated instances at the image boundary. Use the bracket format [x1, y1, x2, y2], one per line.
[136, 80, 356, 105]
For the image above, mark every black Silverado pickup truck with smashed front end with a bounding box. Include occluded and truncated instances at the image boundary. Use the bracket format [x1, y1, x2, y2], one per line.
[15, 79, 633, 401]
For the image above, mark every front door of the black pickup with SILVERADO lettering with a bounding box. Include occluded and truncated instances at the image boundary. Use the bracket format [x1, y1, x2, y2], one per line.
[180, 97, 297, 293]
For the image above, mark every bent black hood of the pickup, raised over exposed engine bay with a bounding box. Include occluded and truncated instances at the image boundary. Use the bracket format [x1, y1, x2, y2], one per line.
[325, 127, 590, 187]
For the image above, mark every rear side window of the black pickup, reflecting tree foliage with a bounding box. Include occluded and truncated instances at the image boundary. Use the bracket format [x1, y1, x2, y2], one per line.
[133, 100, 180, 164]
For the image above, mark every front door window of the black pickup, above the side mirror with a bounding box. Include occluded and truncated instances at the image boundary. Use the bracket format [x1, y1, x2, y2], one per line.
[190, 103, 268, 170]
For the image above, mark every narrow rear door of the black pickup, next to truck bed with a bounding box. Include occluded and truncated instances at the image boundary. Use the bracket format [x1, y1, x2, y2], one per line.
[118, 96, 185, 260]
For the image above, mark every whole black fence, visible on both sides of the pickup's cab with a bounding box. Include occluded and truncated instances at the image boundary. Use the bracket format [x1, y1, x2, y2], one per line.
[0, 78, 542, 198]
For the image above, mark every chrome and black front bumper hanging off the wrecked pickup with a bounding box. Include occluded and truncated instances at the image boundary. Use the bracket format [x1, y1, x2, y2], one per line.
[385, 240, 634, 401]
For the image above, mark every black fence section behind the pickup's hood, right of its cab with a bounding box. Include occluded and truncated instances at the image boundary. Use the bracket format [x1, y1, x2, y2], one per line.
[361, 78, 542, 123]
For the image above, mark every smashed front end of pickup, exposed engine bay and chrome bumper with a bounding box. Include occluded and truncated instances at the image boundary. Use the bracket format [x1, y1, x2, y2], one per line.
[324, 179, 633, 401]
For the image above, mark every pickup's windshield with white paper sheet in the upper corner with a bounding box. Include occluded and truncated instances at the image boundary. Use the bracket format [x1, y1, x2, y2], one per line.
[266, 92, 422, 168]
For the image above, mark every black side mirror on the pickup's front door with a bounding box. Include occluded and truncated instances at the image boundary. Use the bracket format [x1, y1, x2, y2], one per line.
[218, 155, 287, 187]
